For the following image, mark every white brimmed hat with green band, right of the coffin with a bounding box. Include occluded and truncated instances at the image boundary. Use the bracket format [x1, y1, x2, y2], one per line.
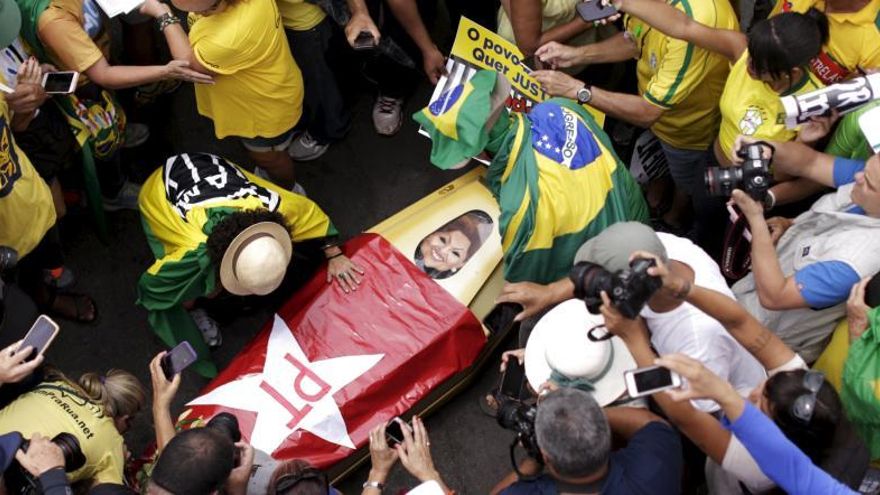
[525, 299, 637, 407]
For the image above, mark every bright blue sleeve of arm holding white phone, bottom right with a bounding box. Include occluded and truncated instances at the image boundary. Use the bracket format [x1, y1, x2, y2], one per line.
[722, 402, 858, 495]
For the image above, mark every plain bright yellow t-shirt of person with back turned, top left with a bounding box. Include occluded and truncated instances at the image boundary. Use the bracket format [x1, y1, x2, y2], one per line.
[189, 0, 303, 138]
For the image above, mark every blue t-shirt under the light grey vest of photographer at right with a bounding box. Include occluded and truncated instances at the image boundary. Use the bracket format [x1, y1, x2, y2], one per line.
[794, 157, 865, 309]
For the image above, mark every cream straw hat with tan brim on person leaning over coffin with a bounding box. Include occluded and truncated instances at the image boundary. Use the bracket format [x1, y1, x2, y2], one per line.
[220, 222, 293, 296]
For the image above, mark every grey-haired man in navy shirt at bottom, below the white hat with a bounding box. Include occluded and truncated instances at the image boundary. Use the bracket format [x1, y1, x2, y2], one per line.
[491, 388, 681, 495]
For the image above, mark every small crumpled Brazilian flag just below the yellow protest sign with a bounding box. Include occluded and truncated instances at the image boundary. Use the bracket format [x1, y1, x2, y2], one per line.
[413, 70, 510, 170]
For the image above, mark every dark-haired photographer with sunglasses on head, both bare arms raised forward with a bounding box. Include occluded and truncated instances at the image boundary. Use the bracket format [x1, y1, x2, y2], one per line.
[601, 252, 869, 493]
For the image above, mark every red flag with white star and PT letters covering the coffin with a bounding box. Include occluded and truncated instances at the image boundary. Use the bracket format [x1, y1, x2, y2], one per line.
[180, 234, 486, 468]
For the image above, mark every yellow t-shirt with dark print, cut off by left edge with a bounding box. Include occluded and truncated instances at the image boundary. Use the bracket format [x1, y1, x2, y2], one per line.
[0, 96, 55, 260]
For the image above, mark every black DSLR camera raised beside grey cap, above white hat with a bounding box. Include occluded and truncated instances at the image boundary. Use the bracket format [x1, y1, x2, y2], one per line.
[568, 258, 663, 320]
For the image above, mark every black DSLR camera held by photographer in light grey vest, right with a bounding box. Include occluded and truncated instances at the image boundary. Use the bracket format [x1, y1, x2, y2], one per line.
[705, 141, 773, 204]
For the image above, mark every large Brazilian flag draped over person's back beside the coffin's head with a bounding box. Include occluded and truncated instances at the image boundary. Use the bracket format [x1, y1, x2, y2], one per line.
[487, 98, 649, 284]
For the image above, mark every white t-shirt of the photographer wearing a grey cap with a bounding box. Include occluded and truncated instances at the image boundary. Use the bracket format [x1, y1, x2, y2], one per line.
[641, 233, 767, 412]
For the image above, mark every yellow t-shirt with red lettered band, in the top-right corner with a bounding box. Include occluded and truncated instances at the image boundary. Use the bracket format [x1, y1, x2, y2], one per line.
[770, 0, 880, 85]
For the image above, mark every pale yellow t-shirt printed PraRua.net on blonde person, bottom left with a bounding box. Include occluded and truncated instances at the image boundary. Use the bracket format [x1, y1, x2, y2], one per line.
[0, 381, 125, 483]
